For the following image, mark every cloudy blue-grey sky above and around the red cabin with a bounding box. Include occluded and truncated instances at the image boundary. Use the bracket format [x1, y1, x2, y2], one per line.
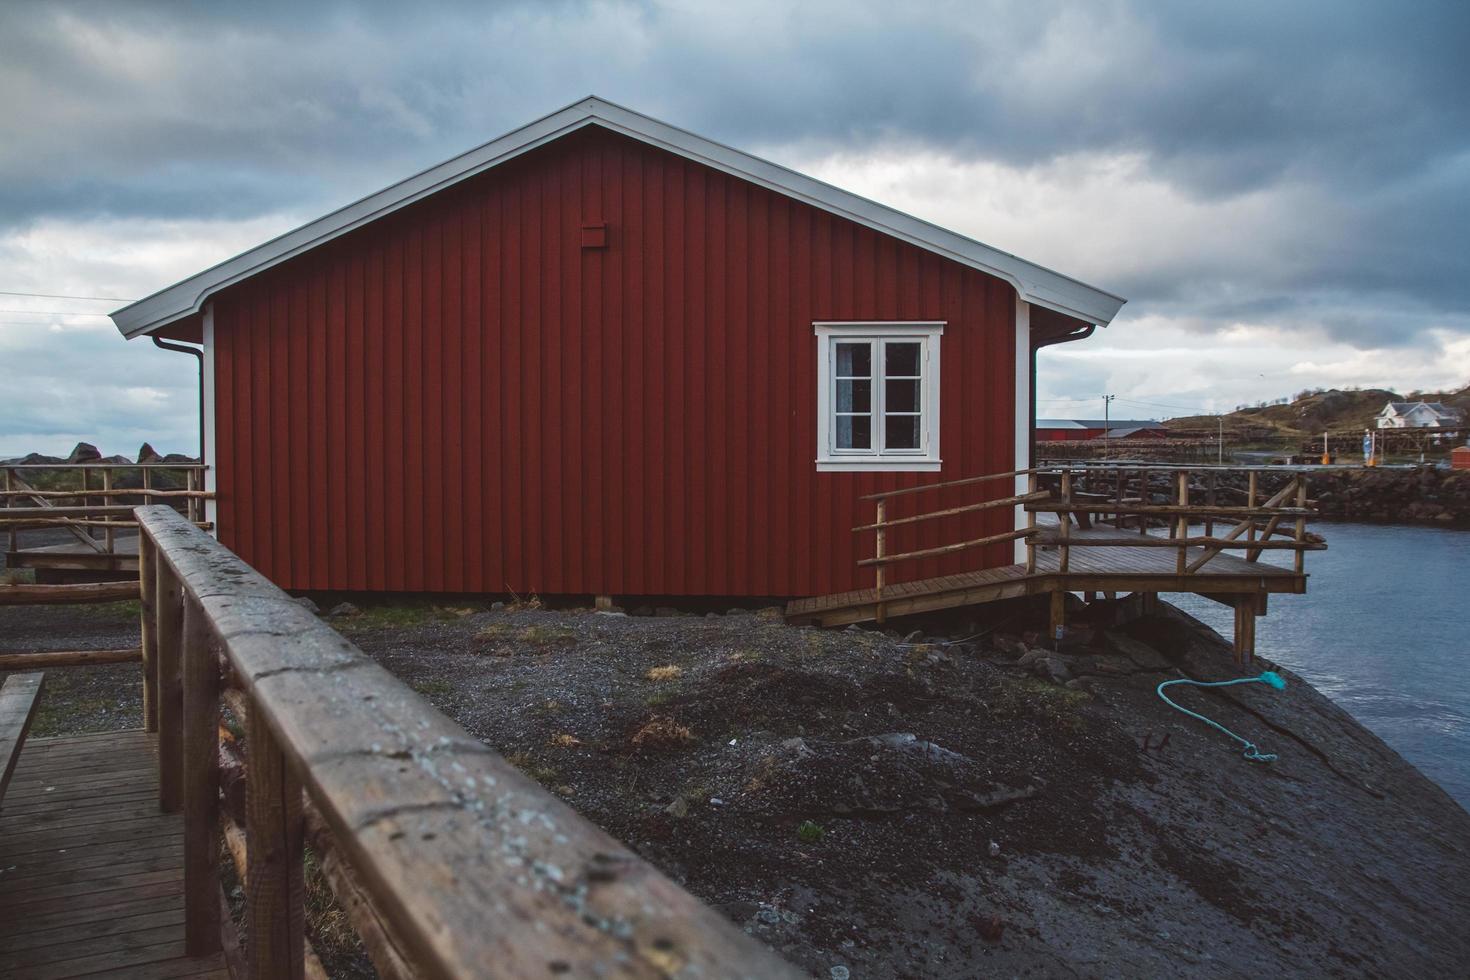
[0, 0, 1470, 457]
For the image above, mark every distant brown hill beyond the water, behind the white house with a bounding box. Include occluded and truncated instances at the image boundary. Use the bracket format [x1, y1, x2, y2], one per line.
[1164, 385, 1470, 439]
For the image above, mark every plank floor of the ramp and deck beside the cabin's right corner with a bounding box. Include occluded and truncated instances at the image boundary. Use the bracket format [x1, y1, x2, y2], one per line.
[786, 527, 1307, 626]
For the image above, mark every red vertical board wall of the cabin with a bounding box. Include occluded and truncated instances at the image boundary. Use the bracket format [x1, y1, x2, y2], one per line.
[212, 126, 1016, 595]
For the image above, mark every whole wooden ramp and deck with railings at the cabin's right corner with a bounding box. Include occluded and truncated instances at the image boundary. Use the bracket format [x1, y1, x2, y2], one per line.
[786, 463, 1326, 661]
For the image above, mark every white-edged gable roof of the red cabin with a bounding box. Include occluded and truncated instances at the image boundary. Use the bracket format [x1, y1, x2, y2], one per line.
[112, 96, 1125, 338]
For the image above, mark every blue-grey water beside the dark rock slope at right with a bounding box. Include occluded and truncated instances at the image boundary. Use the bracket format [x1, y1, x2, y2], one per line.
[1166, 523, 1470, 810]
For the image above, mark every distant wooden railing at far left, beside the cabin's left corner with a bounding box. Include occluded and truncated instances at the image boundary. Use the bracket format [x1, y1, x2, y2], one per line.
[0, 463, 213, 554]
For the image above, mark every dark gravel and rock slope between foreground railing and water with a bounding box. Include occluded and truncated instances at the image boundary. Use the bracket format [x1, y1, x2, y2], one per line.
[334, 605, 1470, 977]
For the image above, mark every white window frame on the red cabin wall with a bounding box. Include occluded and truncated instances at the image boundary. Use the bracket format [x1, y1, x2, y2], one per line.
[811, 320, 945, 473]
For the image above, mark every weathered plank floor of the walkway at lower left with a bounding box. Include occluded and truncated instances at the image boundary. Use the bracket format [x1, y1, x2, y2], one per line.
[0, 732, 229, 980]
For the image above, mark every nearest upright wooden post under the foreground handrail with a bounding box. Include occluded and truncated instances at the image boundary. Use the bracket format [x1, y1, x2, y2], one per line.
[245, 713, 306, 980]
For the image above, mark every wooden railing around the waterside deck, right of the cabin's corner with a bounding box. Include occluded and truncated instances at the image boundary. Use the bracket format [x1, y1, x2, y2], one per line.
[1026, 464, 1326, 576]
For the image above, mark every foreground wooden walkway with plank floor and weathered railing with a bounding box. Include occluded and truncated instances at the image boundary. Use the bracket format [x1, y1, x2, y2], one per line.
[0, 505, 806, 980]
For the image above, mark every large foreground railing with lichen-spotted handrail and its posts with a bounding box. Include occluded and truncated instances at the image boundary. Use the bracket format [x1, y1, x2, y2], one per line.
[137, 505, 803, 979]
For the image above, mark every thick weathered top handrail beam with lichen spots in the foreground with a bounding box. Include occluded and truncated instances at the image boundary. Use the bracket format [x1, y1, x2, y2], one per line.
[138, 507, 806, 980]
